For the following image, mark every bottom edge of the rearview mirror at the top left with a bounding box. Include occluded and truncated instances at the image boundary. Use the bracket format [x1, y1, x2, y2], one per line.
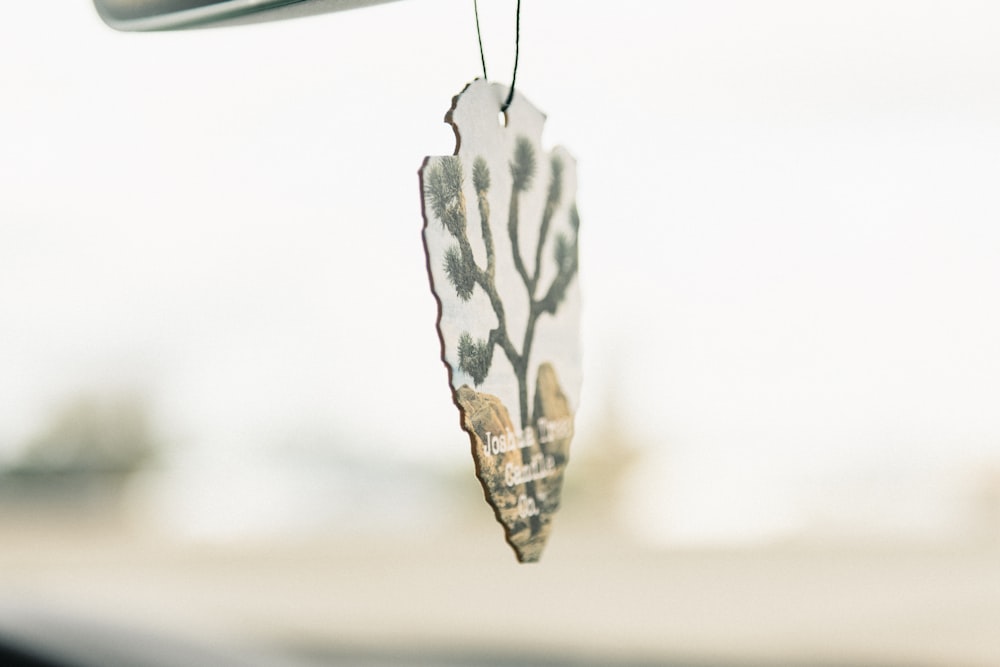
[94, 0, 391, 30]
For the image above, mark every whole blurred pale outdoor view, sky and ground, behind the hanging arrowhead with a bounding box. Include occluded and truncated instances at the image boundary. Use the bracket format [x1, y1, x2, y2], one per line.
[0, 0, 1000, 667]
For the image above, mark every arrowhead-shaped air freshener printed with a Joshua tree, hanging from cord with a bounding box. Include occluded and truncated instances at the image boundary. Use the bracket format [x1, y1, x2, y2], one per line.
[420, 79, 581, 562]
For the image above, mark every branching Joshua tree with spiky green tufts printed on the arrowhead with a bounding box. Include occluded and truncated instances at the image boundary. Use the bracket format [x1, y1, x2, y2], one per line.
[424, 137, 580, 428]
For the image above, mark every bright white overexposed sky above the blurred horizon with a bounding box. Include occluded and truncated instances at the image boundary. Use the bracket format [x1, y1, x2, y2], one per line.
[0, 0, 1000, 543]
